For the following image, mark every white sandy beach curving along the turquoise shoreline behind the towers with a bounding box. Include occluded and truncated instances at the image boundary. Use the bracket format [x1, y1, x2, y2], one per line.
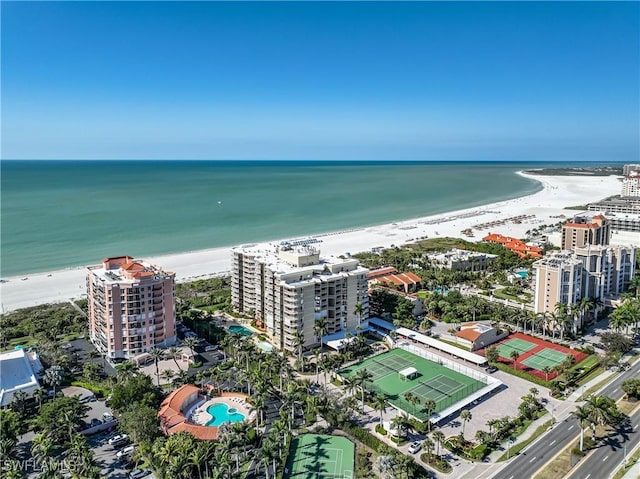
[0, 171, 632, 312]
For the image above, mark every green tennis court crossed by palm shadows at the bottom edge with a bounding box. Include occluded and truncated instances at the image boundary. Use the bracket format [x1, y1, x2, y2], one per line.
[284, 434, 355, 479]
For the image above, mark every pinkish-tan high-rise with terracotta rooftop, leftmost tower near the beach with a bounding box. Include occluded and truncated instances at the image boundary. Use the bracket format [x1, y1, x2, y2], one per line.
[87, 256, 176, 359]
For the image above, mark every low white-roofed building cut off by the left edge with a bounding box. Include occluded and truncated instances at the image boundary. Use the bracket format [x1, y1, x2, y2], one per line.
[0, 349, 43, 407]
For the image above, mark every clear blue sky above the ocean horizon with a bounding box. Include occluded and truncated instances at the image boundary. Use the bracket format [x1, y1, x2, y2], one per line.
[1, 1, 640, 161]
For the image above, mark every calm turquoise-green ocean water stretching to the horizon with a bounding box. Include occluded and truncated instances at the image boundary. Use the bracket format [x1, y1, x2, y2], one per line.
[0, 160, 588, 277]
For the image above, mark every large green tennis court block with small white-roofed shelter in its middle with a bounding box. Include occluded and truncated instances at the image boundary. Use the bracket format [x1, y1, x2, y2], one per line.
[338, 348, 485, 421]
